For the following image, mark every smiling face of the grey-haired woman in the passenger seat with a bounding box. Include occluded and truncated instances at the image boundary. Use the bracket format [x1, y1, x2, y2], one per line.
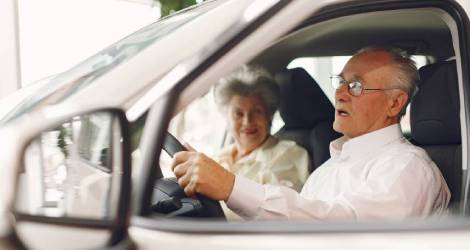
[228, 95, 269, 153]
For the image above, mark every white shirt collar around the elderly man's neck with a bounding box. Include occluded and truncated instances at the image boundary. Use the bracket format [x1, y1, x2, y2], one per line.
[330, 124, 403, 160]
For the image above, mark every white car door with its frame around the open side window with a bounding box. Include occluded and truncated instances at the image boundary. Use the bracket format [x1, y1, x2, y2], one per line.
[129, 1, 470, 249]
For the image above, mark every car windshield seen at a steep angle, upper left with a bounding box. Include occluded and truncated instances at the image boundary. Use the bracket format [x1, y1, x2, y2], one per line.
[0, 1, 223, 124]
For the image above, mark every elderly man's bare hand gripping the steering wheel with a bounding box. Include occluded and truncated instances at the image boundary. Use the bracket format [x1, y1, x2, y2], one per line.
[171, 144, 235, 201]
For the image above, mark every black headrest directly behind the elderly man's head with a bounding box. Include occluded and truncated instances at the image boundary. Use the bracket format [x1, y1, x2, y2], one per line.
[410, 61, 461, 145]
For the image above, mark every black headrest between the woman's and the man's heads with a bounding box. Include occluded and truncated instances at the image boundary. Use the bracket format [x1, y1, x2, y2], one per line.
[275, 68, 334, 129]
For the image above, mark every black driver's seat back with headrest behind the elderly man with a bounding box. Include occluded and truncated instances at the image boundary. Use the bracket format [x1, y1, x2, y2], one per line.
[410, 61, 462, 204]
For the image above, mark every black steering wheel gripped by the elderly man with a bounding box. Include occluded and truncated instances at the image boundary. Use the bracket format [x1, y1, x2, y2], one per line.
[152, 133, 225, 219]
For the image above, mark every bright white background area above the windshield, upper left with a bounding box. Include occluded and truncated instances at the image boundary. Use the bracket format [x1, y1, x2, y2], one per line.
[18, 0, 160, 86]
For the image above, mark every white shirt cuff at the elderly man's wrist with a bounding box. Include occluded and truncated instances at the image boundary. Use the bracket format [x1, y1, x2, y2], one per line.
[227, 175, 264, 218]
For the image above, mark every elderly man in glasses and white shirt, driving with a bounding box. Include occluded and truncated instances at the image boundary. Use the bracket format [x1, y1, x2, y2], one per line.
[172, 47, 450, 220]
